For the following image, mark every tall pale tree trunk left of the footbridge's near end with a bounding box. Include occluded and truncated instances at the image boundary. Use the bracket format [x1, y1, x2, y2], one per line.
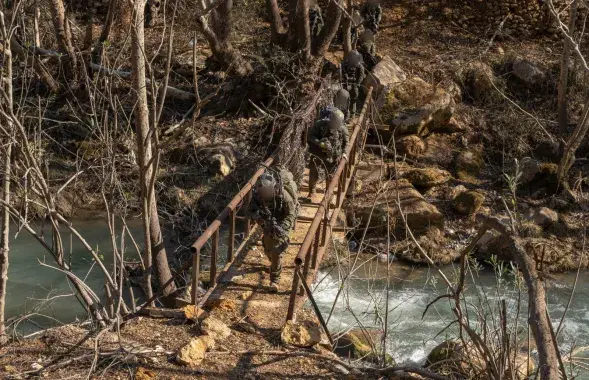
[131, 0, 176, 298]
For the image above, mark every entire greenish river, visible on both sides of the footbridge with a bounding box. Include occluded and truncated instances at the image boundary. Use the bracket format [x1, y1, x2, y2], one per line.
[6, 220, 589, 380]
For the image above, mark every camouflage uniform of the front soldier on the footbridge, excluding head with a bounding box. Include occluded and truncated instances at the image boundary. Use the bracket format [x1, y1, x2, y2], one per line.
[247, 168, 298, 283]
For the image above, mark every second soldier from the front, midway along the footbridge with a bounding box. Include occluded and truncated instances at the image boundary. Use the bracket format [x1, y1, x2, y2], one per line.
[307, 106, 349, 198]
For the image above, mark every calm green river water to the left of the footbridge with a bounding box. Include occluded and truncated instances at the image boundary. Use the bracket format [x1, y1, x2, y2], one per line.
[6, 220, 143, 334]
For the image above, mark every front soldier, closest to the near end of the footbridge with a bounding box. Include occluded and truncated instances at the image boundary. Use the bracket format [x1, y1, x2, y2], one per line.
[247, 168, 298, 293]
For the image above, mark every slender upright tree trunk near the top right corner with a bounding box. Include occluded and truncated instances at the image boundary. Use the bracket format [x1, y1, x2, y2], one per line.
[558, 0, 579, 158]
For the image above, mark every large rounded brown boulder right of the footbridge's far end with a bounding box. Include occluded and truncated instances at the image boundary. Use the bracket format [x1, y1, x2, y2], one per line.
[381, 77, 454, 135]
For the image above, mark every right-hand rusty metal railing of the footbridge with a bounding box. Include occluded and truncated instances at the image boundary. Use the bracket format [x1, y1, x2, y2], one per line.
[286, 87, 372, 322]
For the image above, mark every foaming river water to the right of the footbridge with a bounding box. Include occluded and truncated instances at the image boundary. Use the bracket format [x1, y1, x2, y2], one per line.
[313, 260, 589, 380]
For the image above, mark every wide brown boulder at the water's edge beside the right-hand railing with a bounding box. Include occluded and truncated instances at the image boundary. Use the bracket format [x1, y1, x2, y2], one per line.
[346, 179, 444, 236]
